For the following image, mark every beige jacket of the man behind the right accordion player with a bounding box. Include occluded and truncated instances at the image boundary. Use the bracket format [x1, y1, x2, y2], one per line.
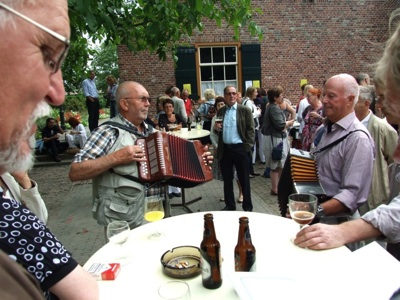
[361, 114, 398, 212]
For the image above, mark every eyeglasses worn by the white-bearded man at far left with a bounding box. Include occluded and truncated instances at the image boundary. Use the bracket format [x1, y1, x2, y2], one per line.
[0, 2, 70, 74]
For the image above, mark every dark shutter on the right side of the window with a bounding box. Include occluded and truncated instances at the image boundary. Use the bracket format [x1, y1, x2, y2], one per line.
[241, 44, 262, 96]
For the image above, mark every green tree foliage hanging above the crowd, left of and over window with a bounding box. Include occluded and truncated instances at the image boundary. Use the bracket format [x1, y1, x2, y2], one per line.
[62, 0, 262, 94]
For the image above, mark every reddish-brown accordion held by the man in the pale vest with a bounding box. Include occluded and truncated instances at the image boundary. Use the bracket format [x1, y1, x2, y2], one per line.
[136, 131, 213, 188]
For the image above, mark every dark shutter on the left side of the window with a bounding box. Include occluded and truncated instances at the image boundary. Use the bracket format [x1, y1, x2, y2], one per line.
[175, 46, 199, 100]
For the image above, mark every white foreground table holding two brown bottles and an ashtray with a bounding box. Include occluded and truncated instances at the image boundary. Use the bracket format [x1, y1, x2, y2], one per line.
[84, 211, 390, 300]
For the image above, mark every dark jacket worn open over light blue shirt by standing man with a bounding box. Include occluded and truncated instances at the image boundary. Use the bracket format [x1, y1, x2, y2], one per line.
[216, 103, 255, 159]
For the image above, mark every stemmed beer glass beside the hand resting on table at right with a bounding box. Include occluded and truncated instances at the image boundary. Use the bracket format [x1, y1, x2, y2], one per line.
[289, 194, 318, 229]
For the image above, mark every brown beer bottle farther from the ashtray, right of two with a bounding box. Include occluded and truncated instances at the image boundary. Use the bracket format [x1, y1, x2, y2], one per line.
[235, 217, 256, 272]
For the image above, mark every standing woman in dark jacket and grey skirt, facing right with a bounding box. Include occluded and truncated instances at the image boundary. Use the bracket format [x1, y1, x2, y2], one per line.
[261, 86, 294, 195]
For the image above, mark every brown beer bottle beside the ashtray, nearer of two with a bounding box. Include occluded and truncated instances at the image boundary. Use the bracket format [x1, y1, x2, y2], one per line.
[200, 214, 222, 289]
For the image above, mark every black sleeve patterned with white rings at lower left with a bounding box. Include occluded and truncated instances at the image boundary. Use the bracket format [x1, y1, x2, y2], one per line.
[0, 188, 78, 296]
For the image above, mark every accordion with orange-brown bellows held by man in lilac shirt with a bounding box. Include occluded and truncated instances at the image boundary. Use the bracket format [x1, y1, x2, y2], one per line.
[278, 148, 326, 217]
